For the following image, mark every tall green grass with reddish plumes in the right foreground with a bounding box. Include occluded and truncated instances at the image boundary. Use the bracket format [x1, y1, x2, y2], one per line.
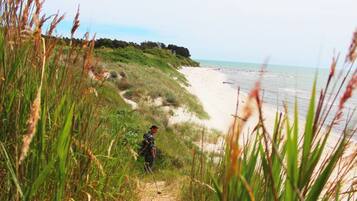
[185, 32, 357, 201]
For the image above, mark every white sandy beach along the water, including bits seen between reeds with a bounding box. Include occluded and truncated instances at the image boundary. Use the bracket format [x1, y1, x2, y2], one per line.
[179, 67, 357, 152]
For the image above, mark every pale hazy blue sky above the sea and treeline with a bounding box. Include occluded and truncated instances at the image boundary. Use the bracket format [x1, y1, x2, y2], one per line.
[44, 0, 357, 67]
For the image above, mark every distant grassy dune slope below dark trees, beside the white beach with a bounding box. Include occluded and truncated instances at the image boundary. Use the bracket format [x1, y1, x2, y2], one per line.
[96, 47, 208, 119]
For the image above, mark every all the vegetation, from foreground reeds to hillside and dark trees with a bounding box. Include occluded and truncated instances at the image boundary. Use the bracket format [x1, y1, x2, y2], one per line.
[0, 0, 357, 201]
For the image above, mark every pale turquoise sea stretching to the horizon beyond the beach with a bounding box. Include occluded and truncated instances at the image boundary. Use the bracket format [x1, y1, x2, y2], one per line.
[198, 60, 357, 140]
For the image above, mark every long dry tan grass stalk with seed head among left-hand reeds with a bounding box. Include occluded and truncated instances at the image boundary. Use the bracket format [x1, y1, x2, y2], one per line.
[19, 38, 46, 164]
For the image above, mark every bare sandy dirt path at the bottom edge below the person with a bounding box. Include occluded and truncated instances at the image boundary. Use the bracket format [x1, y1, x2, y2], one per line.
[139, 181, 178, 201]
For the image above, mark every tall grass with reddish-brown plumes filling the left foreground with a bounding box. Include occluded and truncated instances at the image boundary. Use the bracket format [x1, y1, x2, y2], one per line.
[0, 0, 138, 200]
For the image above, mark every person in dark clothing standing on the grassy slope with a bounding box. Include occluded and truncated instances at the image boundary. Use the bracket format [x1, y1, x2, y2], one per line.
[140, 125, 159, 172]
